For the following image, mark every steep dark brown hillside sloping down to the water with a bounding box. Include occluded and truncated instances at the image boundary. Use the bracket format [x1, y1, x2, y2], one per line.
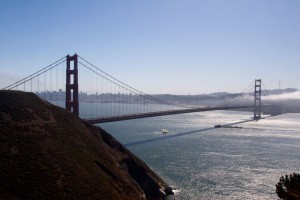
[0, 91, 172, 200]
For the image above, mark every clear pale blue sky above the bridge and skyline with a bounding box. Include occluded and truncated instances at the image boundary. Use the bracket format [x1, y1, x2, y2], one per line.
[0, 0, 300, 94]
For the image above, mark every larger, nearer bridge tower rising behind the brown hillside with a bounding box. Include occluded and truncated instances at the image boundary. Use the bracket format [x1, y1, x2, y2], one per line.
[66, 54, 79, 116]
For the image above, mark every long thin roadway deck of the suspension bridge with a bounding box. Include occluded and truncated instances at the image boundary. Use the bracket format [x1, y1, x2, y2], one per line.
[84, 105, 271, 124]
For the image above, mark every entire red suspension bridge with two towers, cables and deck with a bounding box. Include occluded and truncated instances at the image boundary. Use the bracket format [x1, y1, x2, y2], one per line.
[2, 54, 281, 124]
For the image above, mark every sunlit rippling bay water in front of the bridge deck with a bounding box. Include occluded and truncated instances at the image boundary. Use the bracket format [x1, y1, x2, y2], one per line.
[100, 111, 300, 200]
